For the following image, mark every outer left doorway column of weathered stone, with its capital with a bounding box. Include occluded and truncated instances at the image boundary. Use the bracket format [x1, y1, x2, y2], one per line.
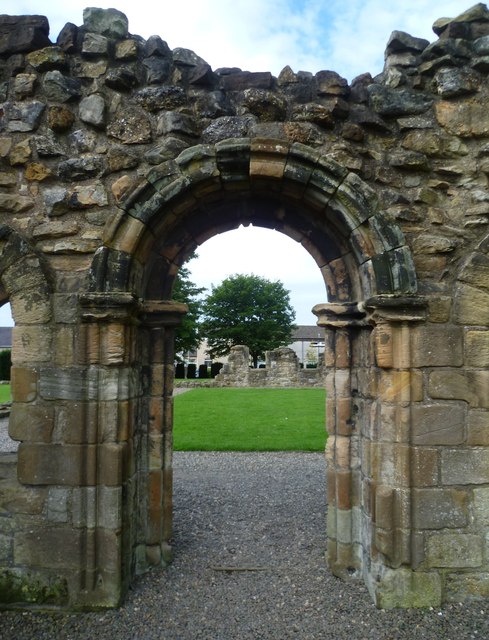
[77, 292, 140, 606]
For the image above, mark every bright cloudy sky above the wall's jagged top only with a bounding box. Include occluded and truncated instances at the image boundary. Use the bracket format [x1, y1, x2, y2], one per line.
[1, 0, 470, 80]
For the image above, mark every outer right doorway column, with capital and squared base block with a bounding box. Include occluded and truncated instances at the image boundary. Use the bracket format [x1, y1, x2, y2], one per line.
[362, 296, 432, 608]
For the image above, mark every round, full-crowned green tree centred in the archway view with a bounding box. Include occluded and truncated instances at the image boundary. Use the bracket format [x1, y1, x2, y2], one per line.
[200, 274, 295, 368]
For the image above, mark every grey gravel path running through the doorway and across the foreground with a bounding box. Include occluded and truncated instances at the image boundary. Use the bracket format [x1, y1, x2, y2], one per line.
[0, 453, 489, 640]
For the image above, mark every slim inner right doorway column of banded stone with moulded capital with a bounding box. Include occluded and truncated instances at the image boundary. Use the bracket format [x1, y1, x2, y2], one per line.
[313, 304, 370, 578]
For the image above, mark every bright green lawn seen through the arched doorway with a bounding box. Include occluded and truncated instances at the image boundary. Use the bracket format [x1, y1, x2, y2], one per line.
[173, 388, 326, 451]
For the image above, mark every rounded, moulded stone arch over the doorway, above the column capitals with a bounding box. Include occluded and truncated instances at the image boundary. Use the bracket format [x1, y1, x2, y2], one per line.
[90, 138, 417, 302]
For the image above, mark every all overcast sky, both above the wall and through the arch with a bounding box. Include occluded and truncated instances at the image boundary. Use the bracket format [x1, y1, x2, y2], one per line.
[0, 0, 474, 325]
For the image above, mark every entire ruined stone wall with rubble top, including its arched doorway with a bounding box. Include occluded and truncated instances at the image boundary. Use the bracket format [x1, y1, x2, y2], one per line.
[0, 5, 489, 608]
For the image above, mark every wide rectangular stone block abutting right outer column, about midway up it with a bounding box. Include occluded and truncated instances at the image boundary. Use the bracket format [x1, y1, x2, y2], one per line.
[412, 403, 466, 445]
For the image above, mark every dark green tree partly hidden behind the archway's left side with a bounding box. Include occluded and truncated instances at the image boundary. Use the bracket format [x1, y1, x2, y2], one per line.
[172, 255, 205, 360]
